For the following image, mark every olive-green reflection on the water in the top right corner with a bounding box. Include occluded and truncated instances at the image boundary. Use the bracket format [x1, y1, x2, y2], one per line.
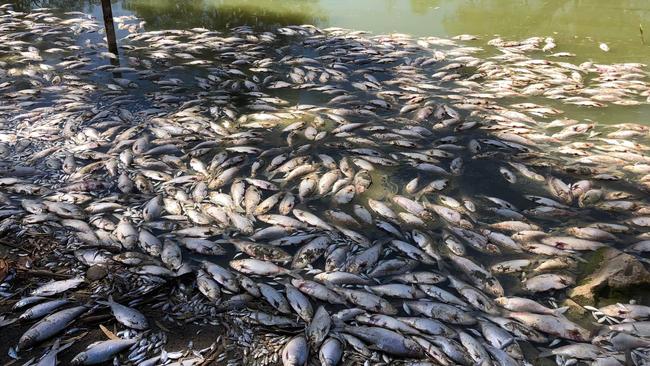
[443, 0, 650, 62]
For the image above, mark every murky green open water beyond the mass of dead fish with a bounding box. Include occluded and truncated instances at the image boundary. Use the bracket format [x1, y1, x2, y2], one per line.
[7, 0, 650, 124]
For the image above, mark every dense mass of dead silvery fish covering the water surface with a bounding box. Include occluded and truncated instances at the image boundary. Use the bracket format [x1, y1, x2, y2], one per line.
[0, 6, 650, 365]
